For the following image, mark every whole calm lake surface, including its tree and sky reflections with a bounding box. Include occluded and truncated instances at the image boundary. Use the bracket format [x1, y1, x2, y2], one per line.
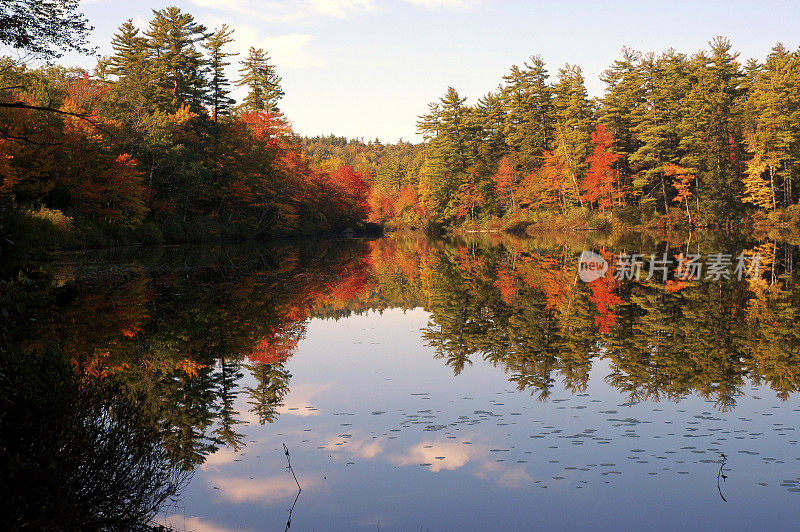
[6, 235, 800, 530]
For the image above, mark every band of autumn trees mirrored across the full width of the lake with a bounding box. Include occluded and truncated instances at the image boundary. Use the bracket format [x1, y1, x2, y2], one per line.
[0, 234, 800, 498]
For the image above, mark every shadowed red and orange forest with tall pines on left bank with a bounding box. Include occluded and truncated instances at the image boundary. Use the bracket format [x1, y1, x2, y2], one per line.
[0, 7, 376, 264]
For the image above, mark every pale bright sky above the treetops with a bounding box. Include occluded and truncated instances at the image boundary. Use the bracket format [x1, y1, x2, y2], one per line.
[65, 0, 800, 141]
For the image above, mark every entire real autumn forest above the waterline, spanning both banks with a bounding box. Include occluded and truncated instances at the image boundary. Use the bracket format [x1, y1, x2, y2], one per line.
[0, 7, 800, 270]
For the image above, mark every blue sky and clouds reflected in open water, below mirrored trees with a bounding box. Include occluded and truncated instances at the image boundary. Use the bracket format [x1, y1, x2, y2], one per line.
[153, 235, 800, 530]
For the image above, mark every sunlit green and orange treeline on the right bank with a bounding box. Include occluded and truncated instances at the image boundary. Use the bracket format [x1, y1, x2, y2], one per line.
[310, 38, 800, 233]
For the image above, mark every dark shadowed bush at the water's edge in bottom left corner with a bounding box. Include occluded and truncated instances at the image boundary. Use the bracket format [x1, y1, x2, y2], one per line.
[0, 351, 187, 530]
